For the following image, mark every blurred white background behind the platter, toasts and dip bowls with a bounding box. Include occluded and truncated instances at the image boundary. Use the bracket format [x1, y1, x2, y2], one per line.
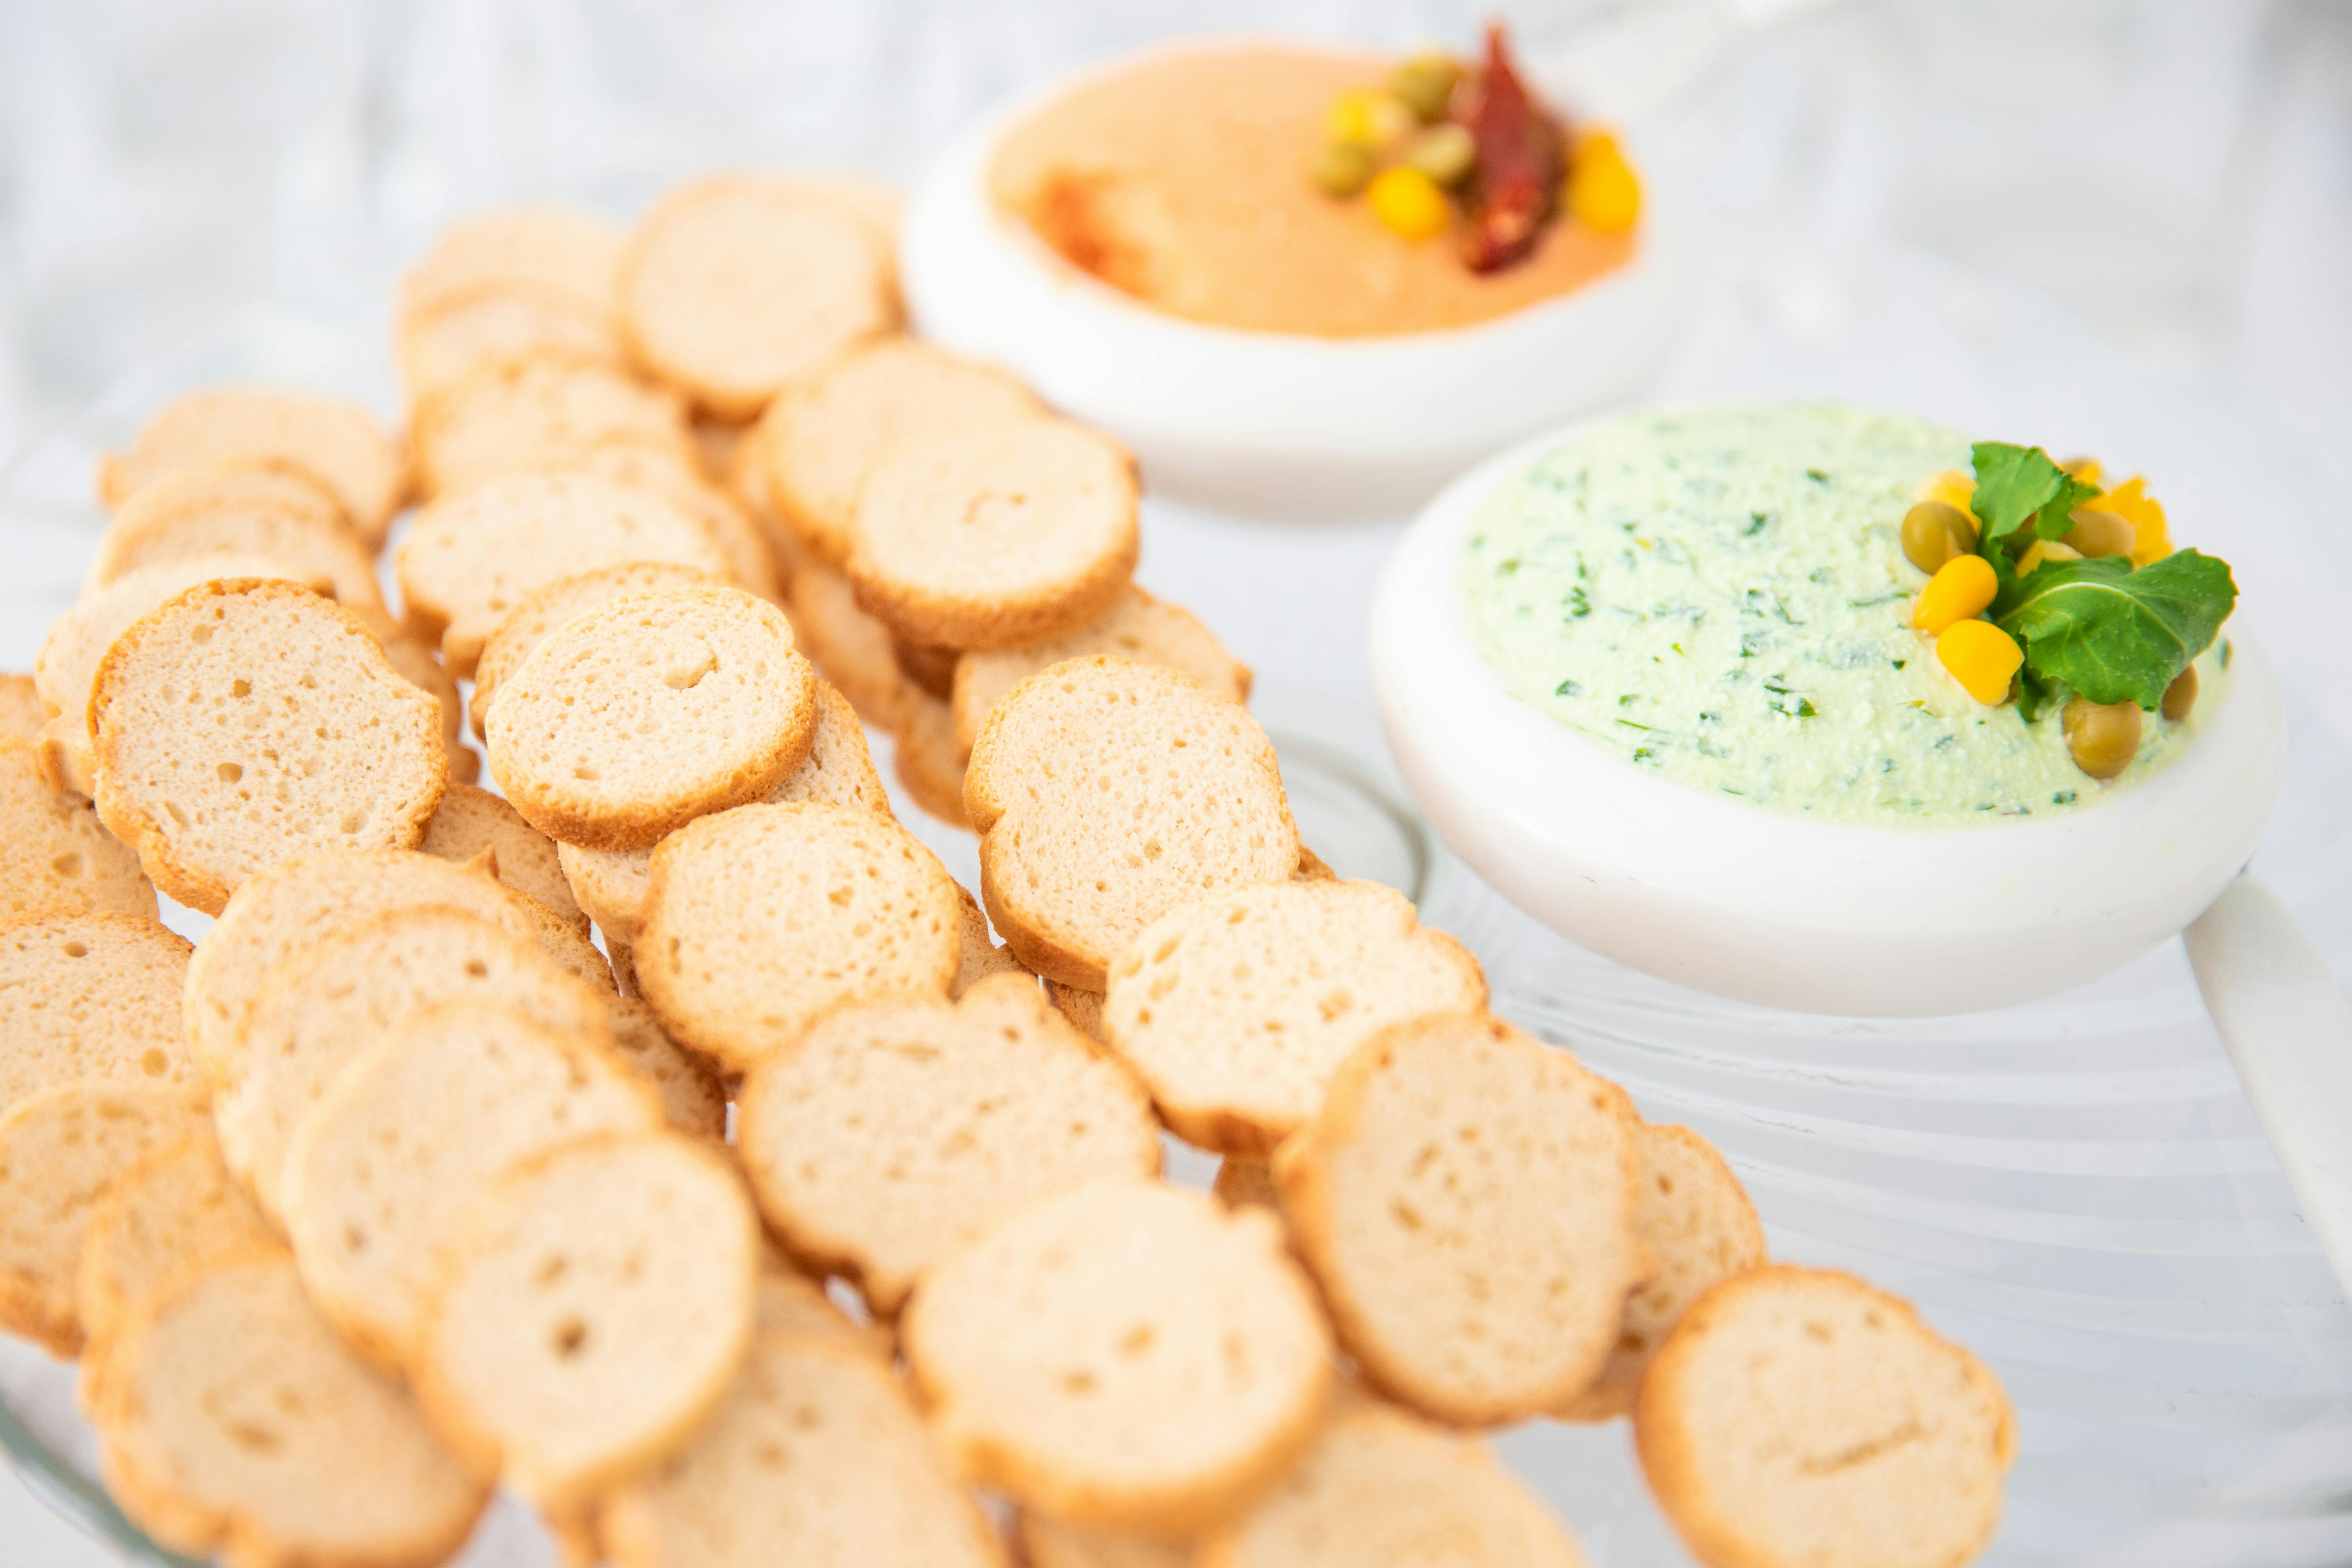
[0, 0, 2352, 1568]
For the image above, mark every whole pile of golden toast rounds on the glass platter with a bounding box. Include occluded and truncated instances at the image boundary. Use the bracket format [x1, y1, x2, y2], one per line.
[0, 174, 2013, 1568]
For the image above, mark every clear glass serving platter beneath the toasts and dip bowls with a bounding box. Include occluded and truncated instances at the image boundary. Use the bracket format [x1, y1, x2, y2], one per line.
[0, 270, 2352, 1568]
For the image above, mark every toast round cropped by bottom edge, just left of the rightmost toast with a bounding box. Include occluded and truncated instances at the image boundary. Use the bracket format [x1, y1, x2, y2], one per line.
[1199, 1401, 1585, 1568]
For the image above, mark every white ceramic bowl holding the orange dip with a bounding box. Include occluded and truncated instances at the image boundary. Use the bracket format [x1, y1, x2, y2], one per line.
[898, 40, 1689, 520]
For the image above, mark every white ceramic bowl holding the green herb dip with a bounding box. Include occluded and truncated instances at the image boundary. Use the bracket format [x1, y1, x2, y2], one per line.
[1371, 416, 2286, 1018]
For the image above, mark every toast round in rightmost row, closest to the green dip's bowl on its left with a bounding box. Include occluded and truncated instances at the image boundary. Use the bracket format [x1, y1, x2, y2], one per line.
[964, 653, 1298, 992]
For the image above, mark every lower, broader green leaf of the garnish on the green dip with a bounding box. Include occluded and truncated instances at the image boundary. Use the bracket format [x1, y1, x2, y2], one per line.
[1992, 550, 2237, 710]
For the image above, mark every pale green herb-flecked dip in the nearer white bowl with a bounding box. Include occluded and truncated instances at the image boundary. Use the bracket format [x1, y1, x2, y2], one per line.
[1461, 405, 2230, 825]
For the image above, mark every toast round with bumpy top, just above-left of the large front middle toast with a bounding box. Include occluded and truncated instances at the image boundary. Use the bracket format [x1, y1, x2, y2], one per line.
[736, 976, 1159, 1314]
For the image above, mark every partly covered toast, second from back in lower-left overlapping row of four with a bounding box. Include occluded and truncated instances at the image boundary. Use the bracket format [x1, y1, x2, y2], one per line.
[212, 905, 611, 1215]
